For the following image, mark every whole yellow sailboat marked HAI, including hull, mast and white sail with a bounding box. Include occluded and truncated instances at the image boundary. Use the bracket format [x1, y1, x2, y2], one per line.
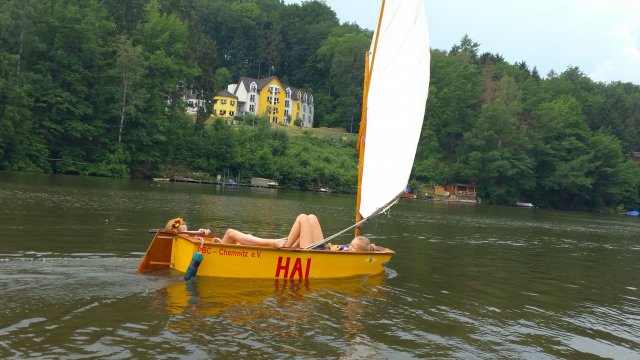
[138, 0, 430, 279]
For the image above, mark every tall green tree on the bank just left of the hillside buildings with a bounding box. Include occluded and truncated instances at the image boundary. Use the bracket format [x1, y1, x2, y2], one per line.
[129, 0, 199, 166]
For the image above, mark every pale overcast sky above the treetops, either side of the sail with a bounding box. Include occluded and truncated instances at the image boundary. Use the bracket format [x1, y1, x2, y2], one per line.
[285, 0, 640, 84]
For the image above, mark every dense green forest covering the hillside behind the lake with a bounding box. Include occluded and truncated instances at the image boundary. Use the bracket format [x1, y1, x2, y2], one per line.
[0, 0, 640, 210]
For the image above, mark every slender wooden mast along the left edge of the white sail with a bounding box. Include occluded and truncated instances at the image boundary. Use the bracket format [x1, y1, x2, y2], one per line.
[355, 0, 385, 236]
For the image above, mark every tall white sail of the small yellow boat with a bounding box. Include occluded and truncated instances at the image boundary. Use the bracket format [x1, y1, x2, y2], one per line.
[359, 0, 430, 218]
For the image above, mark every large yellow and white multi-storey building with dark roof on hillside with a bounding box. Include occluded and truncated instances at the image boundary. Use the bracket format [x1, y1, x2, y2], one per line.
[227, 76, 314, 127]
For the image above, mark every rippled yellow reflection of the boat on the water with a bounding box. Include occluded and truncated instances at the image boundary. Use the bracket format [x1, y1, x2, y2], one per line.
[152, 270, 386, 344]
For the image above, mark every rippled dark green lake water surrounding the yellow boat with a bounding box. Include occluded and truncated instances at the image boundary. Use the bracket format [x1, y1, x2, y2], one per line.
[0, 172, 640, 359]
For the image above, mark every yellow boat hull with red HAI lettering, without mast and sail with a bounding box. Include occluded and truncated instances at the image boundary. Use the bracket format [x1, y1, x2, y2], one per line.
[138, 231, 395, 279]
